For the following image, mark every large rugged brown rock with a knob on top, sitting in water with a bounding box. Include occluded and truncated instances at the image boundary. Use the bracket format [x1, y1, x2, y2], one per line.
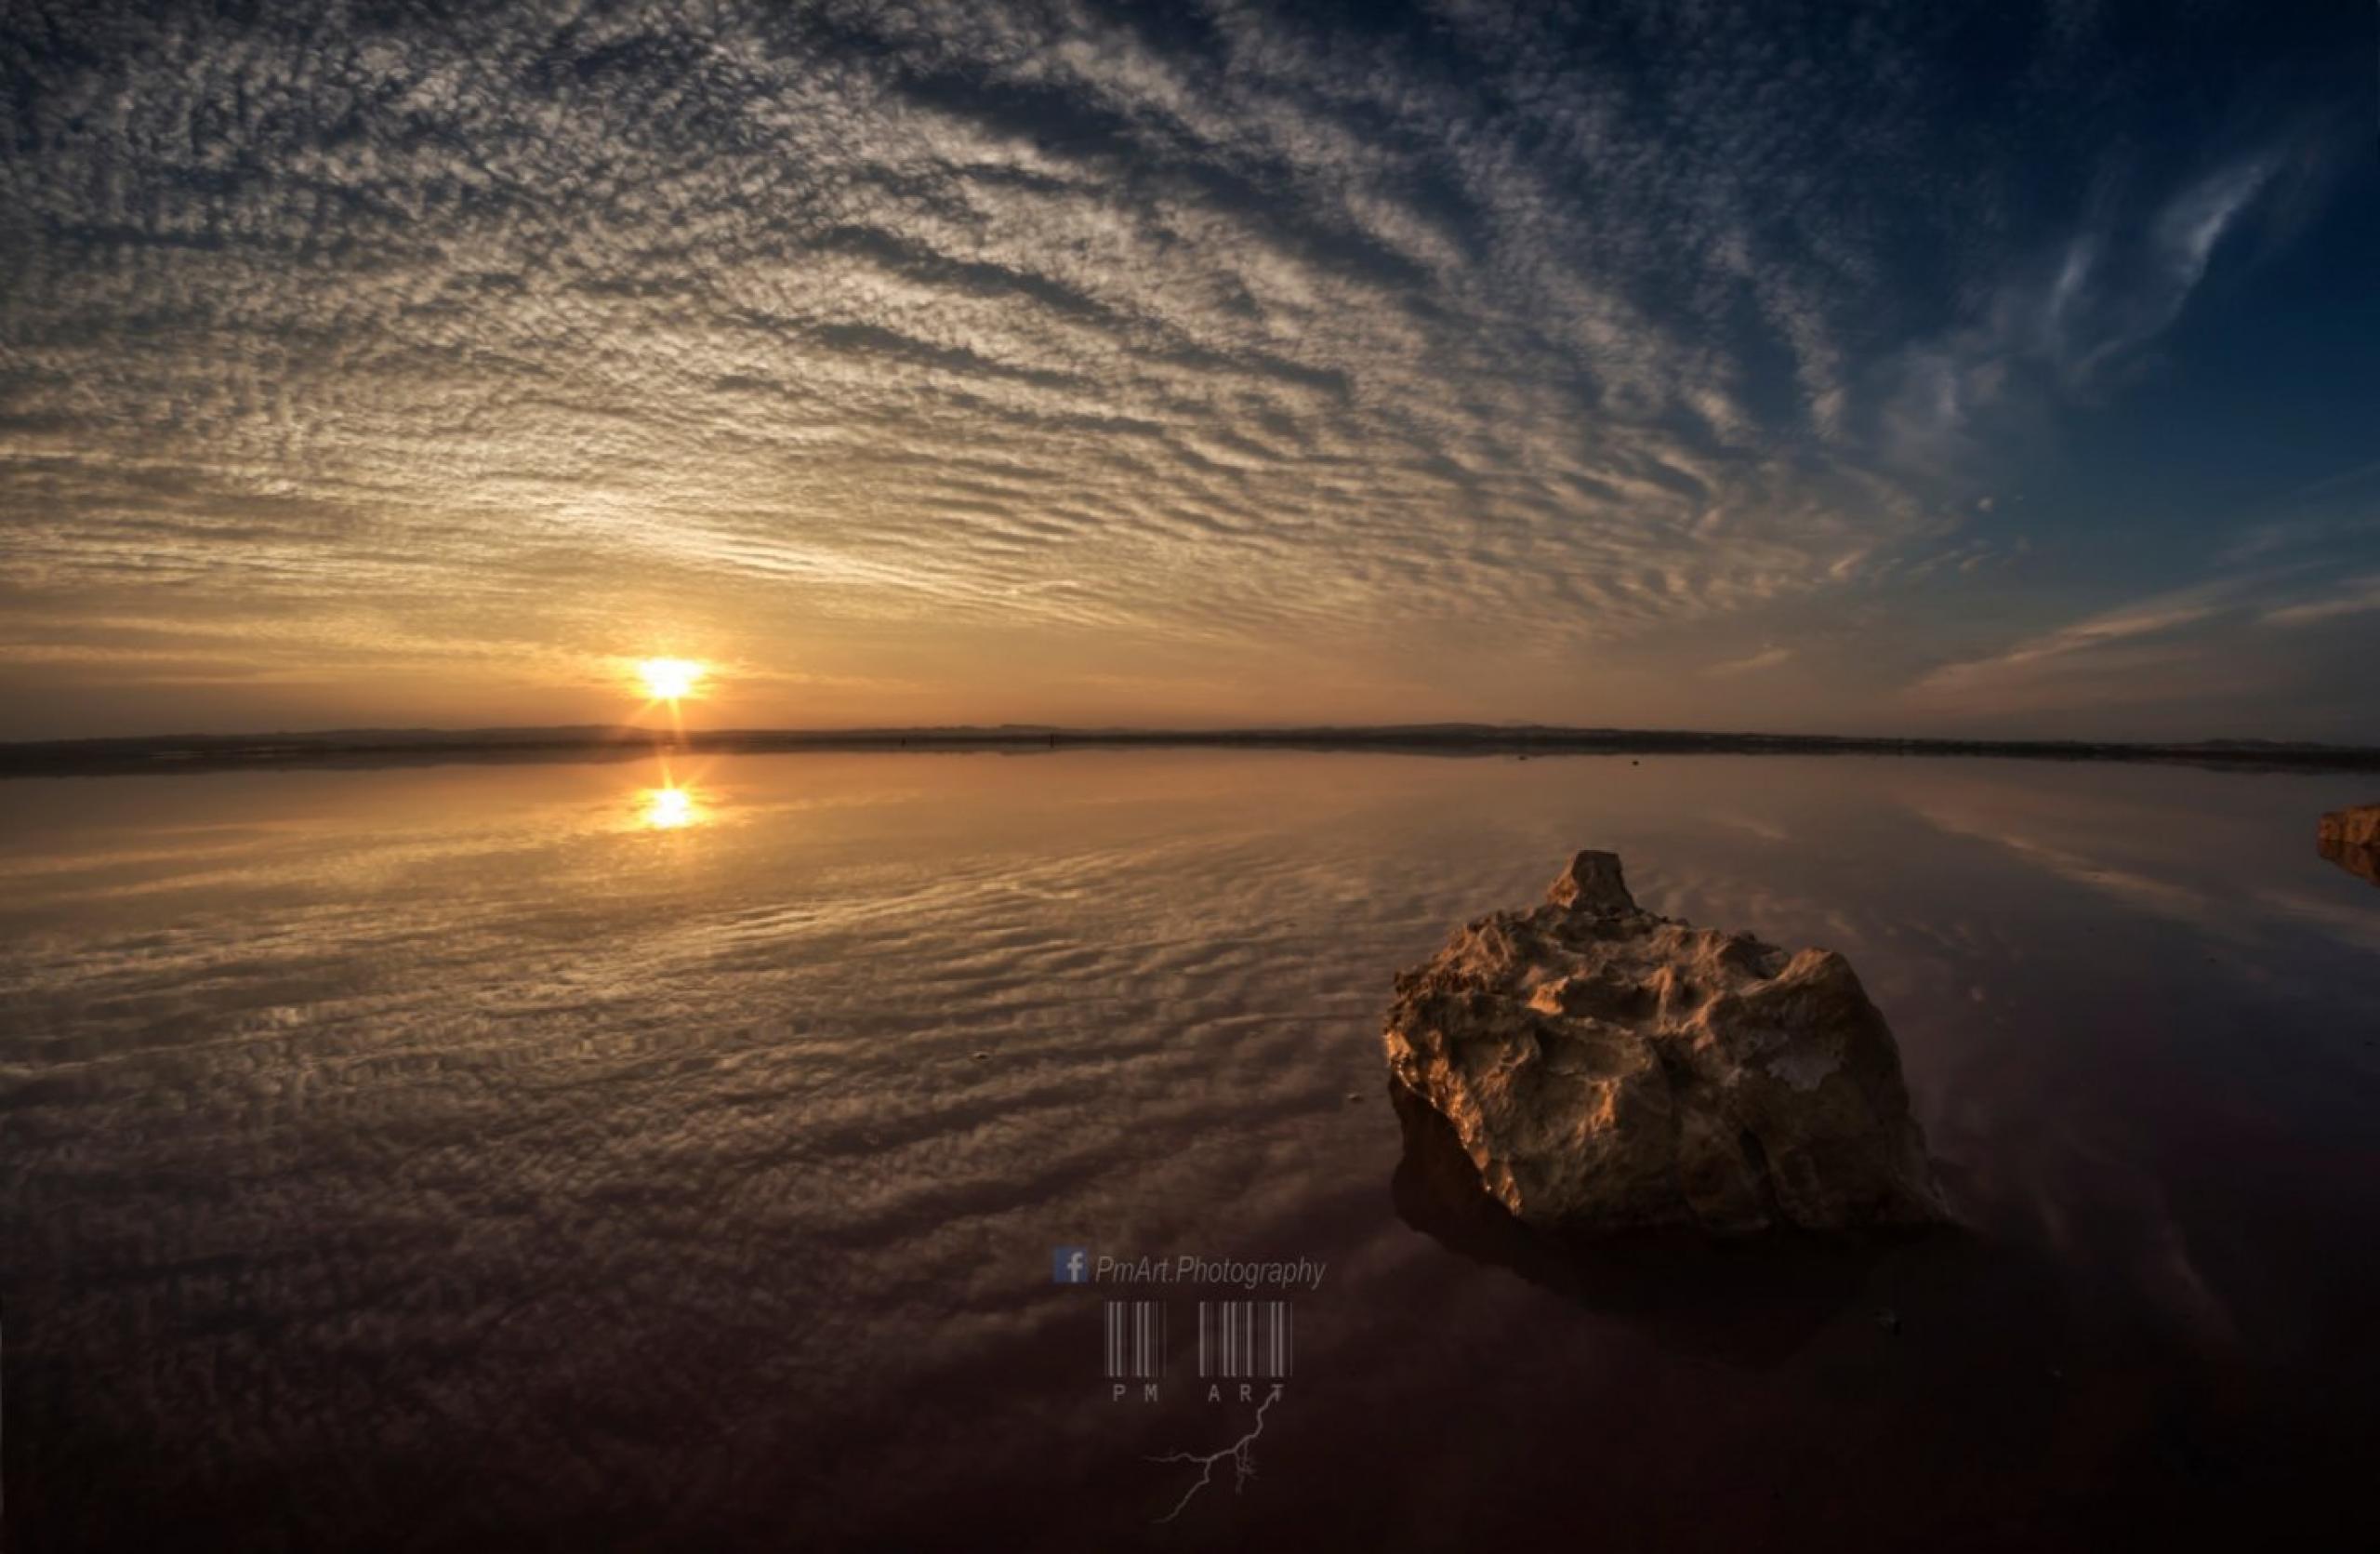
[1385, 852, 1945, 1233]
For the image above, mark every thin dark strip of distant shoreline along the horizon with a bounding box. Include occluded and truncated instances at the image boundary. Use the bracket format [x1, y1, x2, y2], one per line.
[14, 724, 2380, 778]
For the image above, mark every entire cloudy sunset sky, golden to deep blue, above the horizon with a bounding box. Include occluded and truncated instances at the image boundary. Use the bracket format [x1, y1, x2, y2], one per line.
[0, 0, 2380, 742]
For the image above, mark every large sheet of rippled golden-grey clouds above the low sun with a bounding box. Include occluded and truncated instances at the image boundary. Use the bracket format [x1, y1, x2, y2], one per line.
[0, 0, 2360, 733]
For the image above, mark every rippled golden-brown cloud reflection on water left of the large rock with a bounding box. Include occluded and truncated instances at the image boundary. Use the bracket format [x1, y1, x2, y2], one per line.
[9, 756, 1428, 1494]
